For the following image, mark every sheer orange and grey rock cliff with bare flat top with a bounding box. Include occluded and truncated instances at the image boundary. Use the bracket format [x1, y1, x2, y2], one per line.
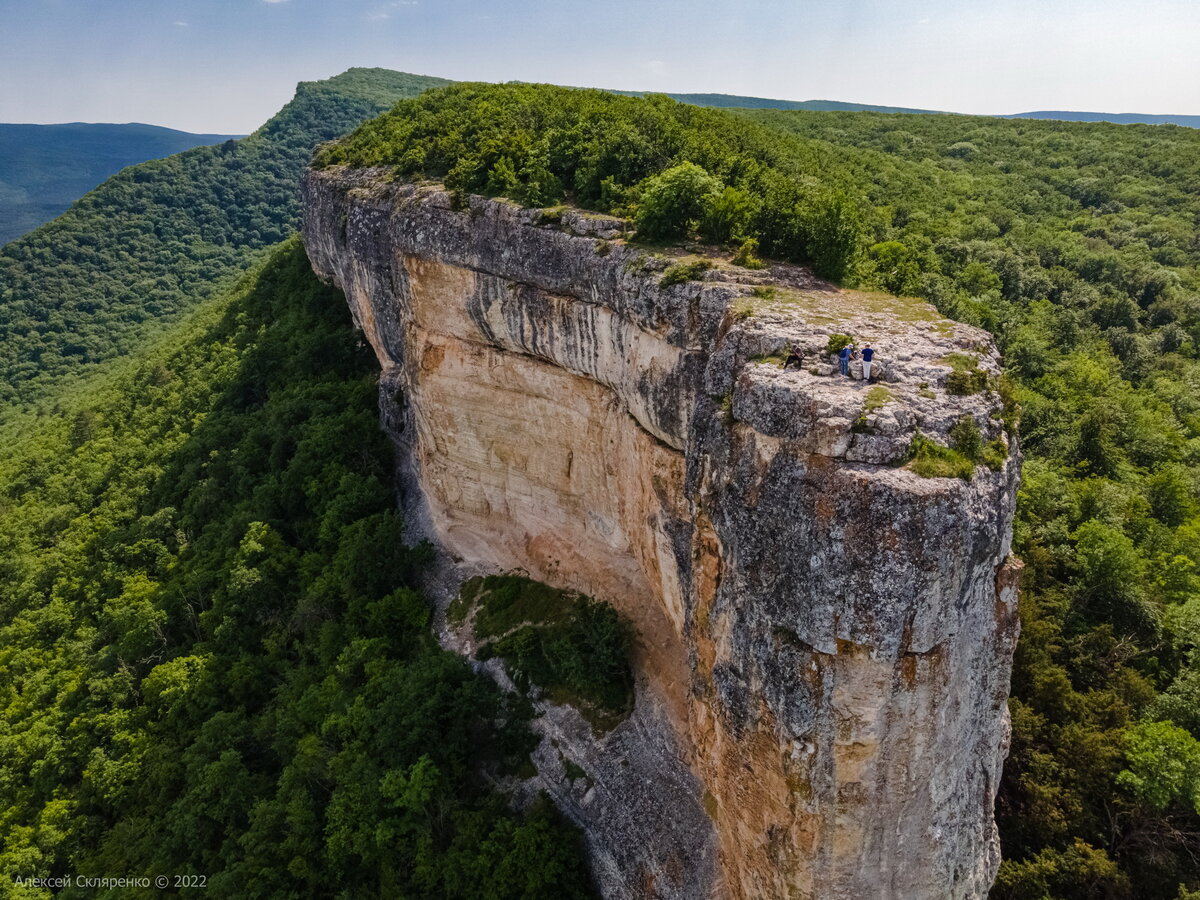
[305, 170, 1018, 900]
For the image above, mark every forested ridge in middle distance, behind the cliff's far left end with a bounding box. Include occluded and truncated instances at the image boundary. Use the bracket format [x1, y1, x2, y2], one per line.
[0, 70, 444, 415]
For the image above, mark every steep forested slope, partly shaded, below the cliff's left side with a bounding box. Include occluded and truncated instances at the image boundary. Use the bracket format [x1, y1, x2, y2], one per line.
[0, 239, 588, 900]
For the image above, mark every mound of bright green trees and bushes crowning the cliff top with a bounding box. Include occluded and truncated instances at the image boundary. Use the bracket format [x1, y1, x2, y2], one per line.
[316, 84, 859, 280]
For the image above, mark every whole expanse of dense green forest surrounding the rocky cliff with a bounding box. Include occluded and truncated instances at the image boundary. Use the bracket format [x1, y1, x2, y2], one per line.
[0, 71, 1200, 900]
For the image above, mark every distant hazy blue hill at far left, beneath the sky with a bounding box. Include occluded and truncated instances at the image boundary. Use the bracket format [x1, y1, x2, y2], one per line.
[0, 122, 240, 245]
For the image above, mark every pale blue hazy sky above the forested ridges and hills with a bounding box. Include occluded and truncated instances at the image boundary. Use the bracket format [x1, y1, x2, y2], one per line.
[0, 0, 1200, 134]
